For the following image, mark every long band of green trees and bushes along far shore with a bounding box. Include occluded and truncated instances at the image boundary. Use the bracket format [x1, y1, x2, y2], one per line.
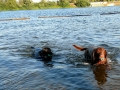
[0, 0, 120, 11]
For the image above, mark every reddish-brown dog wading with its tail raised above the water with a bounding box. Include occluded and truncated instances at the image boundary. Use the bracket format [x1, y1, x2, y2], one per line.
[73, 45, 108, 65]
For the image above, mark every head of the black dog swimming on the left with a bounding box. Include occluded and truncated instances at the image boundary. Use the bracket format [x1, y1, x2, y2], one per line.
[39, 47, 52, 61]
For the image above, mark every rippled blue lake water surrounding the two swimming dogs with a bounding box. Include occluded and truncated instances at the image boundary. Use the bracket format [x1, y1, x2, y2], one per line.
[0, 7, 120, 90]
